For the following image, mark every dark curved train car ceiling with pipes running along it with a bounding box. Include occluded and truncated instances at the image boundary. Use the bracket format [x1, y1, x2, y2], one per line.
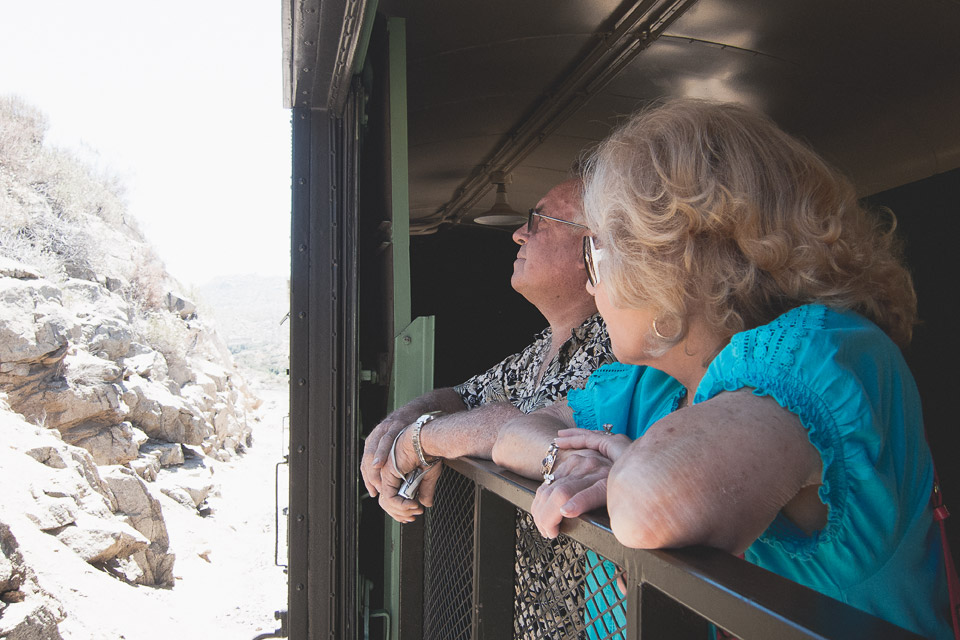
[284, 0, 960, 234]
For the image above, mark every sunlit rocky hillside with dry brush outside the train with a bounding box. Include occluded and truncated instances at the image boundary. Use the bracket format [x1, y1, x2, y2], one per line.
[0, 97, 259, 640]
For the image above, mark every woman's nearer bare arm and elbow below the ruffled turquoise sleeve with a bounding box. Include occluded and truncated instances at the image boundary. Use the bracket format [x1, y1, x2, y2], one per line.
[607, 390, 826, 553]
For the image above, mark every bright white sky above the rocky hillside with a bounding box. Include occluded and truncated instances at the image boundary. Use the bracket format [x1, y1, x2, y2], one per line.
[0, 0, 290, 285]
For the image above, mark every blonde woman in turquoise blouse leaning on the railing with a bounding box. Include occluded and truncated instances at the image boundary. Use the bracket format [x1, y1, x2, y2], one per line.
[493, 100, 950, 638]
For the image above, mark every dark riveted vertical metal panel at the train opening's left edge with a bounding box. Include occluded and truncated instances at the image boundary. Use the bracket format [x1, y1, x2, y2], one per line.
[288, 96, 358, 640]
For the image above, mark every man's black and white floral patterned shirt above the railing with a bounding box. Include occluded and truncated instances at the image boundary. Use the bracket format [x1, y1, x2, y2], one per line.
[454, 314, 616, 413]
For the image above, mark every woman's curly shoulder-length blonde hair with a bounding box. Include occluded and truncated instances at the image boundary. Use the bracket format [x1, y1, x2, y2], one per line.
[584, 99, 917, 353]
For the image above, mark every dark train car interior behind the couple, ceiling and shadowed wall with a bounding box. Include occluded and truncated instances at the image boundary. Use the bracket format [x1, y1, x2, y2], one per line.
[361, 0, 960, 420]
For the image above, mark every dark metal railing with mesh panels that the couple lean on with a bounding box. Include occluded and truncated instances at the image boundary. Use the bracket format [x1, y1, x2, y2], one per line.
[423, 459, 919, 640]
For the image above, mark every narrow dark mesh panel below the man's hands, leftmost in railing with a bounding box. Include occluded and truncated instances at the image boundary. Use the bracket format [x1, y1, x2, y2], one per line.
[423, 469, 474, 640]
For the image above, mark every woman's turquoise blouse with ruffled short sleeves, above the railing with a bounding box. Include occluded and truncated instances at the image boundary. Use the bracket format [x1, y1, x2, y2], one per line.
[569, 305, 952, 638]
